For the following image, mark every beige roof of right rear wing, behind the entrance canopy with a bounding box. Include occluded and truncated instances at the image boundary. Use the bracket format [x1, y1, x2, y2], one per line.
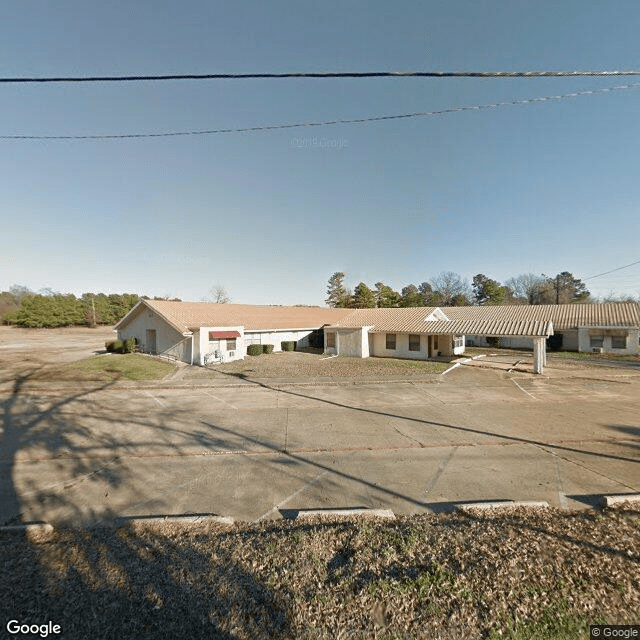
[442, 302, 640, 331]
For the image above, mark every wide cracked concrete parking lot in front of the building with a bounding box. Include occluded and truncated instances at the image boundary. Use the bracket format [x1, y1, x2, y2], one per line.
[0, 330, 640, 524]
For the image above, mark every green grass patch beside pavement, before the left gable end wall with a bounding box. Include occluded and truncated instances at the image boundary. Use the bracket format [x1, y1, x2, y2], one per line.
[34, 353, 176, 382]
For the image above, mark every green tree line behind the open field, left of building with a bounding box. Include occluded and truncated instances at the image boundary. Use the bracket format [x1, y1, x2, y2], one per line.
[0, 285, 179, 327]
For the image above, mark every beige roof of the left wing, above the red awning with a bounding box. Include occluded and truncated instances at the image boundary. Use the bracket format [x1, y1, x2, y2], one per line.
[116, 300, 351, 333]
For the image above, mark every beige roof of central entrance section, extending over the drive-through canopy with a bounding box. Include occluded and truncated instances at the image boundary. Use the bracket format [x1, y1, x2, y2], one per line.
[333, 307, 553, 336]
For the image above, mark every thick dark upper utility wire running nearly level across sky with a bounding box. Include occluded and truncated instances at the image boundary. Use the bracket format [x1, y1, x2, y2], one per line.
[0, 69, 640, 83]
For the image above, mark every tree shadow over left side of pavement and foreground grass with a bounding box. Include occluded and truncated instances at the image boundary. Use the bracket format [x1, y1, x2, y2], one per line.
[0, 372, 289, 640]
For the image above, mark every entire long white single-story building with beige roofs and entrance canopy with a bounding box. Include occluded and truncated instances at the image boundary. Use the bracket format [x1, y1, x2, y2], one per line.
[115, 300, 640, 373]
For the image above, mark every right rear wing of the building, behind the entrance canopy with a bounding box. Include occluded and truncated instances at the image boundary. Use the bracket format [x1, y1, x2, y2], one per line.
[456, 302, 640, 355]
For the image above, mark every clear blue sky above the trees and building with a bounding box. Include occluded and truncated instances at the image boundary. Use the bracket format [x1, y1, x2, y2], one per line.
[0, 0, 640, 304]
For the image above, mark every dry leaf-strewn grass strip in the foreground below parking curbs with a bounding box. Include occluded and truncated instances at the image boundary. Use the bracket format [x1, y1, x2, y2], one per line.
[0, 510, 640, 640]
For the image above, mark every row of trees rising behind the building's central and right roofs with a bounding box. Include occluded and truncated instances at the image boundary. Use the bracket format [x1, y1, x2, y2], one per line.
[325, 271, 634, 309]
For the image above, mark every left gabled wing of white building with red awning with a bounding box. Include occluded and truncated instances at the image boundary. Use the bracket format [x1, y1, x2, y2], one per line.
[114, 300, 352, 365]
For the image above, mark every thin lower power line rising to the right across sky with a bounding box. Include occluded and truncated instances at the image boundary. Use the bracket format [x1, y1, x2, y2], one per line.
[0, 82, 640, 140]
